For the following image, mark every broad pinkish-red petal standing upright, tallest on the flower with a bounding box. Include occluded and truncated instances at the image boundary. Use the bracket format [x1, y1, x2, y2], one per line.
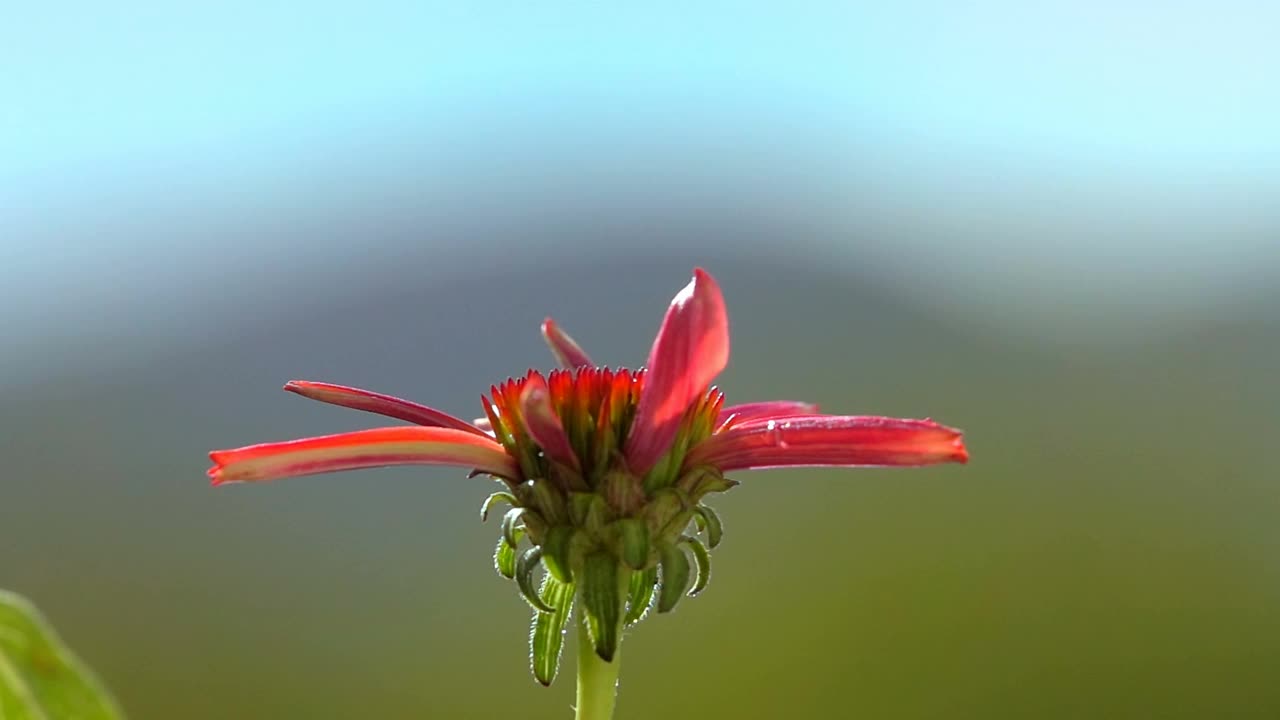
[626, 268, 728, 474]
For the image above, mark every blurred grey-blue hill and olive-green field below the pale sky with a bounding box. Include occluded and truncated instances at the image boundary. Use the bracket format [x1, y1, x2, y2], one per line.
[0, 258, 1280, 720]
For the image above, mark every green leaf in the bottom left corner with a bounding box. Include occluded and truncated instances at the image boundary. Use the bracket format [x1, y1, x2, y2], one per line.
[0, 591, 124, 720]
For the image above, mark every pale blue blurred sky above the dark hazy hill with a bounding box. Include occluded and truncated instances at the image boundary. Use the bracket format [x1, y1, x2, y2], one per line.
[0, 0, 1280, 358]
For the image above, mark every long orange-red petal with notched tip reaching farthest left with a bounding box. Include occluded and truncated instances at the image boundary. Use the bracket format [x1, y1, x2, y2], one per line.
[207, 428, 520, 486]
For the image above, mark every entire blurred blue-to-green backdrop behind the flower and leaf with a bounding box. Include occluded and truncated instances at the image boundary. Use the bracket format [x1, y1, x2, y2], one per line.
[0, 0, 1280, 720]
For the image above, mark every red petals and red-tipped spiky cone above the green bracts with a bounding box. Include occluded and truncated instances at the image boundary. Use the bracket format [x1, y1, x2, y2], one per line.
[209, 269, 968, 489]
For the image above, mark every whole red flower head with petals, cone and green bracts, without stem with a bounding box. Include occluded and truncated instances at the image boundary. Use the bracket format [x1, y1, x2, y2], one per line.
[209, 269, 968, 684]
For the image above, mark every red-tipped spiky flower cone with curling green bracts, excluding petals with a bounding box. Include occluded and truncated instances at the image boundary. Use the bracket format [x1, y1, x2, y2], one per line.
[484, 368, 736, 683]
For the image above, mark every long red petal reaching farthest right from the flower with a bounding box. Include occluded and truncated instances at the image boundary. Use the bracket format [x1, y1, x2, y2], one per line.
[685, 415, 969, 471]
